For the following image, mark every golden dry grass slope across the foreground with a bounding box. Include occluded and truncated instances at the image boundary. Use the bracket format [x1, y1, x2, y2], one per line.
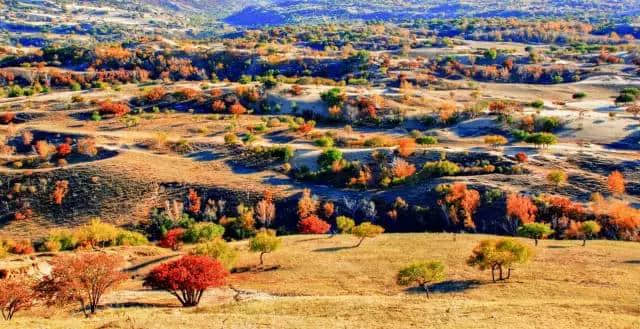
[0, 234, 640, 328]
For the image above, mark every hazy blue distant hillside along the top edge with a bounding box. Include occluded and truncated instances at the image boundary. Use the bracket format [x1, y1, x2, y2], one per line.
[221, 0, 640, 26]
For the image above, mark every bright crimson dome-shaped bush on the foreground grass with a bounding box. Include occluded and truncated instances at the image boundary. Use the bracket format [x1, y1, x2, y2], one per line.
[144, 255, 229, 307]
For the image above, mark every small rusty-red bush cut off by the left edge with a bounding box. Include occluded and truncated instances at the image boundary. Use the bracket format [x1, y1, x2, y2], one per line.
[0, 277, 36, 320]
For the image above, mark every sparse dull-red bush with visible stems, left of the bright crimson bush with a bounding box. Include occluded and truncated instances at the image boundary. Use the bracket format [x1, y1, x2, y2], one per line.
[36, 253, 127, 317]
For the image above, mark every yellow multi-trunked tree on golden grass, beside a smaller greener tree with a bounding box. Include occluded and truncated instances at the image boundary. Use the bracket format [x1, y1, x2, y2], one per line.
[467, 239, 532, 282]
